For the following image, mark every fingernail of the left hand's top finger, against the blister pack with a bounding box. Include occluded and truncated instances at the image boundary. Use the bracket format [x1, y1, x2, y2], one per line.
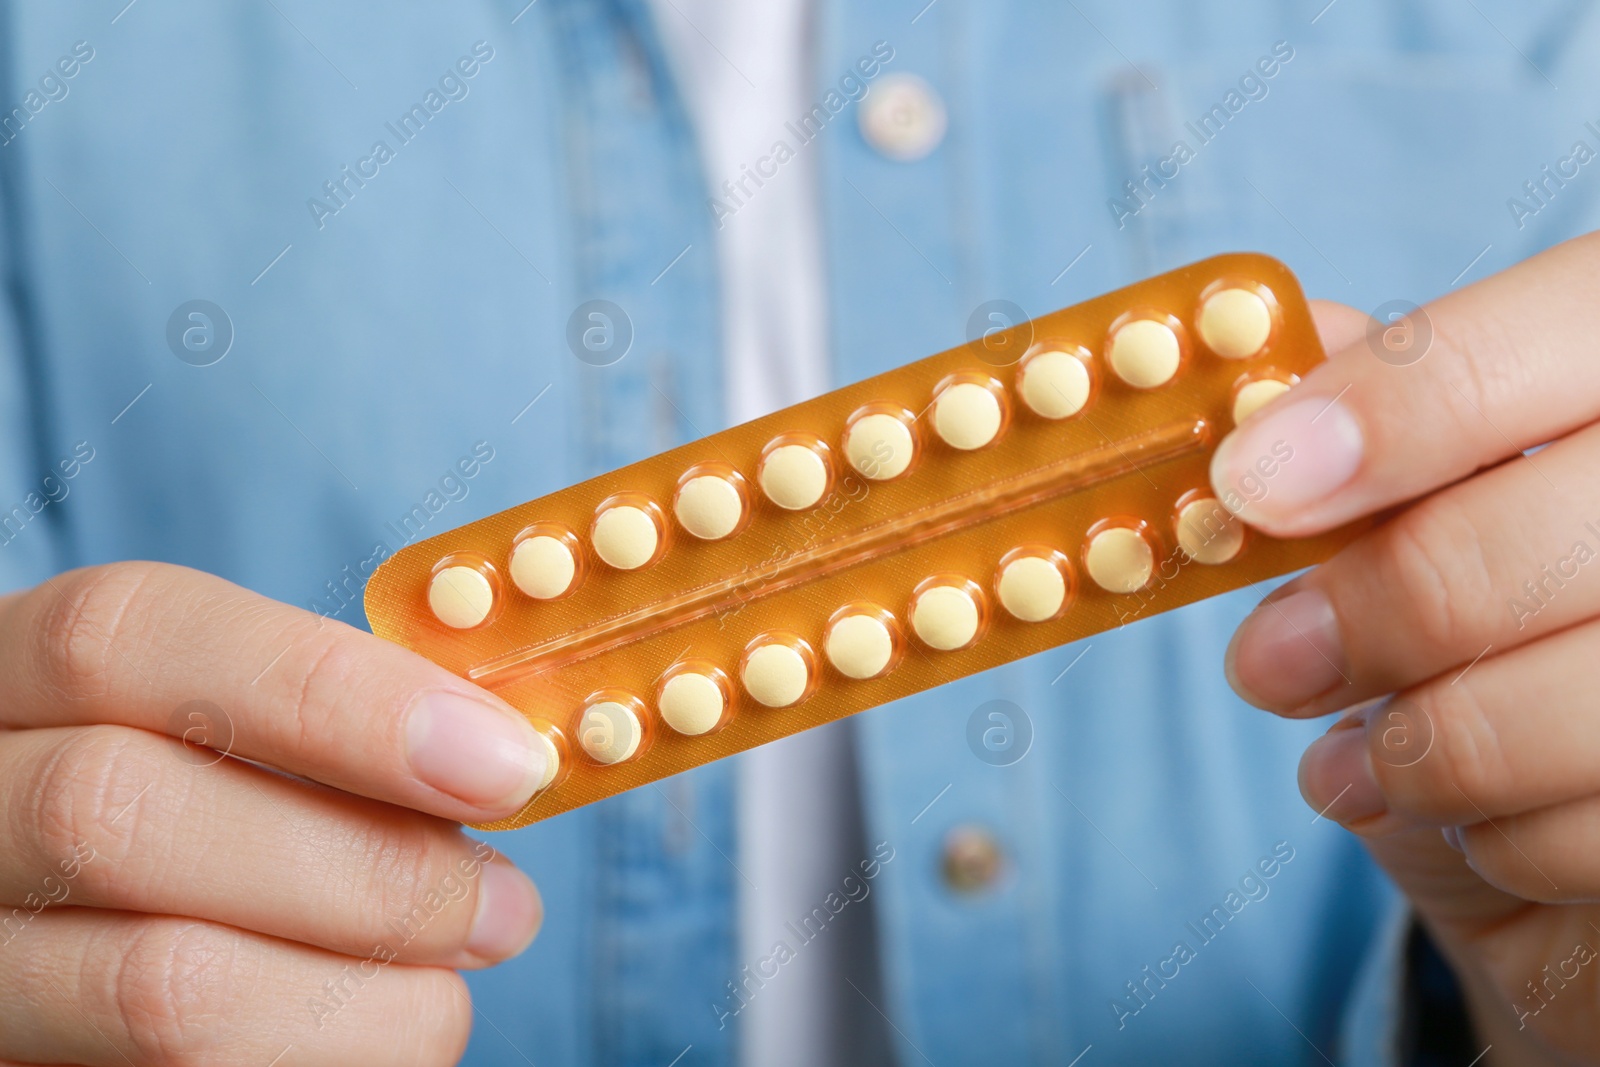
[405, 689, 546, 809]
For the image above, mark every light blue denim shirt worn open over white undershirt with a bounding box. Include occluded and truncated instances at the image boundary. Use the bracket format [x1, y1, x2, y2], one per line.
[0, 0, 1600, 1067]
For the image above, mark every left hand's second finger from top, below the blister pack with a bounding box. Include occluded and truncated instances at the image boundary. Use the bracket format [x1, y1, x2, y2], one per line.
[0, 726, 541, 968]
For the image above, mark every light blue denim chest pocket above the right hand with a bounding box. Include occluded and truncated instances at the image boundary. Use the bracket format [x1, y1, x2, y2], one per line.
[1106, 43, 1600, 309]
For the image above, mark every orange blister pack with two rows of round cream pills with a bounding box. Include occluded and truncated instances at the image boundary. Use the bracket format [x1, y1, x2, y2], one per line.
[366, 254, 1360, 830]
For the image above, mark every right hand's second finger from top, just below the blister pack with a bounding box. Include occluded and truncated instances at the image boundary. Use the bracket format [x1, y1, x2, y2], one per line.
[1226, 412, 1600, 715]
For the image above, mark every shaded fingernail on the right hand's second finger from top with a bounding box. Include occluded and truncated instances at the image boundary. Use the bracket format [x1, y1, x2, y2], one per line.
[1226, 589, 1349, 710]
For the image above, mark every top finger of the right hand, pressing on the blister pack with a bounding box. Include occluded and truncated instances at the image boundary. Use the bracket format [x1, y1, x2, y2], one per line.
[1211, 234, 1600, 536]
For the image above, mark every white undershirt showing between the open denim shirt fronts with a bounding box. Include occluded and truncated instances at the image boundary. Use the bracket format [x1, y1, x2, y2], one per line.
[653, 0, 861, 1067]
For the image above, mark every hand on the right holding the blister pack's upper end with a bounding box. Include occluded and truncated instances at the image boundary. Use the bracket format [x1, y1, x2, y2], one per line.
[1211, 235, 1600, 1062]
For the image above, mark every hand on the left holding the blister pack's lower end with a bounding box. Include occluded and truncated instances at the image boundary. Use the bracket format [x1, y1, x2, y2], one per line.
[0, 563, 544, 1067]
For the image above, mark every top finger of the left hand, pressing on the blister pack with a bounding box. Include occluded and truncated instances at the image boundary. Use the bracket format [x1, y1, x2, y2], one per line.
[0, 563, 549, 822]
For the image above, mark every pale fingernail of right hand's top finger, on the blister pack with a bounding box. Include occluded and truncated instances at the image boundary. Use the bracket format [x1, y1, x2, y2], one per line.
[1211, 397, 1362, 528]
